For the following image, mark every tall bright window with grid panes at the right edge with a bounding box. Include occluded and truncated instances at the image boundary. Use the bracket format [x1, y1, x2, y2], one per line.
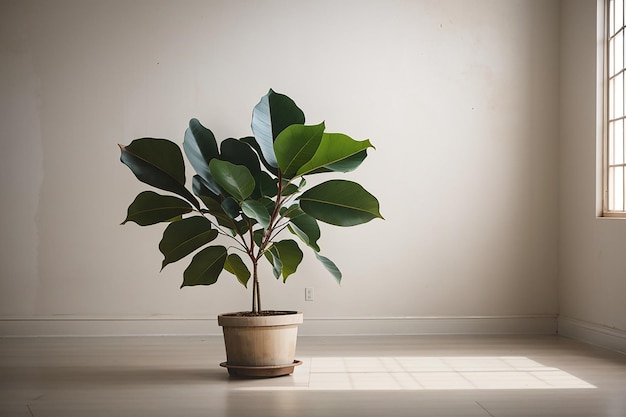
[603, 0, 626, 217]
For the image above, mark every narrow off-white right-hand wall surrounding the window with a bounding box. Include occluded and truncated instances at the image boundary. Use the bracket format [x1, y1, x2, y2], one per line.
[559, 0, 626, 351]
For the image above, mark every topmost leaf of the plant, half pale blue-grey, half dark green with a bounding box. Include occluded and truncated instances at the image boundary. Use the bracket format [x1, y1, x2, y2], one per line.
[252, 89, 304, 168]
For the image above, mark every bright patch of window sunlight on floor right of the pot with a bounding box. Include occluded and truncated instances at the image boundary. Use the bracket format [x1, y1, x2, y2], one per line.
[232, 356, 596, 390]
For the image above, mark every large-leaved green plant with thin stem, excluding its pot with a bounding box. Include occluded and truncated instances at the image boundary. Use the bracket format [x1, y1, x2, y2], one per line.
[119, 90, 382, 314]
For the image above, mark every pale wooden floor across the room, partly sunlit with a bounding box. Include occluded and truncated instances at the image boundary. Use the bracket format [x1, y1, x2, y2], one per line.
[0, 336, 626, 417]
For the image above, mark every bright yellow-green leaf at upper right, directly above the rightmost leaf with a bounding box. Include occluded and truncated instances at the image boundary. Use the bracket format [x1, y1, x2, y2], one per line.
[297, 133, 373, 175]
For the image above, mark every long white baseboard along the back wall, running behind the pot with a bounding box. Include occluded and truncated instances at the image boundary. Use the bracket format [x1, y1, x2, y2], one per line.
[0, 314, 557, 337]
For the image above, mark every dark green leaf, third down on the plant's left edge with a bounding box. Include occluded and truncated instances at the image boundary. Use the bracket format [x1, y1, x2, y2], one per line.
[159, 216, 218, 269]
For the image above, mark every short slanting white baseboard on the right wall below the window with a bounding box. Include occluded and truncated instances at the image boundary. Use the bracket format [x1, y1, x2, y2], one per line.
[558, 316, 626, 354]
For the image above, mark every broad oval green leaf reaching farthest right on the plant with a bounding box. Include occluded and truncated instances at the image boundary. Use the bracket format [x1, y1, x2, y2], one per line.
[299, 180, 383, 226]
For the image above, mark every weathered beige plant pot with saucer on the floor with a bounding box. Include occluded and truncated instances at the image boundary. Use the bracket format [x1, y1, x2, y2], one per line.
[217, 311, 303, 377]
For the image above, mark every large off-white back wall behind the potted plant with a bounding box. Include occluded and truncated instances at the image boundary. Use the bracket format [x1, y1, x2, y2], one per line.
[0, 0, 560, 333]
